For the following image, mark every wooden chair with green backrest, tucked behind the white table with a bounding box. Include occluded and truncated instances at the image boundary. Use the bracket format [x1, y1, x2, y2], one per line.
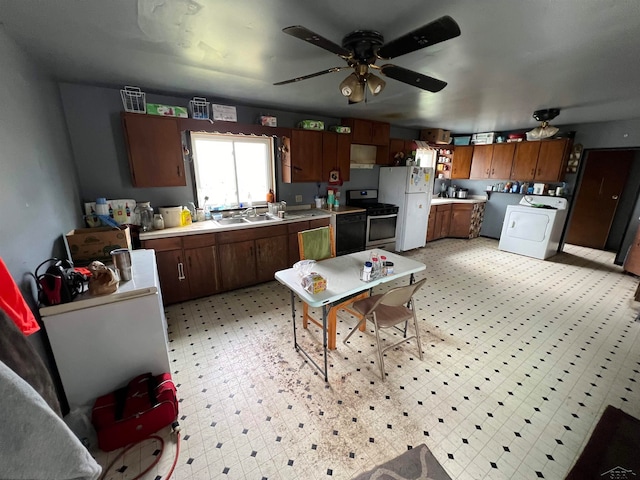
[298, 225, 369, 350]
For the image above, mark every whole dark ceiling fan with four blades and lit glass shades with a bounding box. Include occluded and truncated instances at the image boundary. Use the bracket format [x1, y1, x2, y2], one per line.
[274, 15, 460, 103]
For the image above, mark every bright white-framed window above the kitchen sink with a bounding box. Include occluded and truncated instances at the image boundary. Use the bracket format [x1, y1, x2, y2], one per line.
[191, 133, 275, 209]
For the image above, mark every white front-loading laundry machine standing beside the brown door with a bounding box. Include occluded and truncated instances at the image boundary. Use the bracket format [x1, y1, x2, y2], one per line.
[498, 195, 568, 260]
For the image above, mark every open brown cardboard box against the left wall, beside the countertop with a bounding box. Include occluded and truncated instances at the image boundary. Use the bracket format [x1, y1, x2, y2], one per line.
[65, 226, 131, 266]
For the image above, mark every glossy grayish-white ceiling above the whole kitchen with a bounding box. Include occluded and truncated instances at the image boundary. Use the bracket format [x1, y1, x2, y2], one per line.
[0, 0, 640, 133]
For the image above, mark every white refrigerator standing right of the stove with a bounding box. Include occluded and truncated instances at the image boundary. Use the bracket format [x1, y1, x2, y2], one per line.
[378, 166, 434, 252]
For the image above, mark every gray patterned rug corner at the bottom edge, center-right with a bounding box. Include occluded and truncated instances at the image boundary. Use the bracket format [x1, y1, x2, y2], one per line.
[353, 443, 451, 480]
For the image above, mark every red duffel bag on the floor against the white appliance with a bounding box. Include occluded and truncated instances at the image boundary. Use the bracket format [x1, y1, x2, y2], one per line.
[91, 373, 178, 452]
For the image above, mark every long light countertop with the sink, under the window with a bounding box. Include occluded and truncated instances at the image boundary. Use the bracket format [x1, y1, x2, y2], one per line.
[140, 207, 330, 241]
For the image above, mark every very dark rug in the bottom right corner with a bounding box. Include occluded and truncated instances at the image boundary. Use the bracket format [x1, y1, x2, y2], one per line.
[566, 405, 640, 480]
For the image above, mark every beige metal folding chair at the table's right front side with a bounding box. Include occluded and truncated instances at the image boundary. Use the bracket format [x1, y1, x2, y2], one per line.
[343, 278, 427, 382]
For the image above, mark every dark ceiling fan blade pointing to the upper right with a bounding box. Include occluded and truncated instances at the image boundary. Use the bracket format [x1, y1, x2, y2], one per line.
[378, 15, 460, 59]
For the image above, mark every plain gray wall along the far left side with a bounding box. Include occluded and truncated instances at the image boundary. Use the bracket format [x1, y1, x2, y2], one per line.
[0, 29, 82, 394]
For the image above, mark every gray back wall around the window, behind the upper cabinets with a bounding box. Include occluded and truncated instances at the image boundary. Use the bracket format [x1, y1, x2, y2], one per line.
[60, 83, 418, 211]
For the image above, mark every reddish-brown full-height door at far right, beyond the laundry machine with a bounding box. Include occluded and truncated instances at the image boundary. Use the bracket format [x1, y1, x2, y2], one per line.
[565, 150, 634, 250]
